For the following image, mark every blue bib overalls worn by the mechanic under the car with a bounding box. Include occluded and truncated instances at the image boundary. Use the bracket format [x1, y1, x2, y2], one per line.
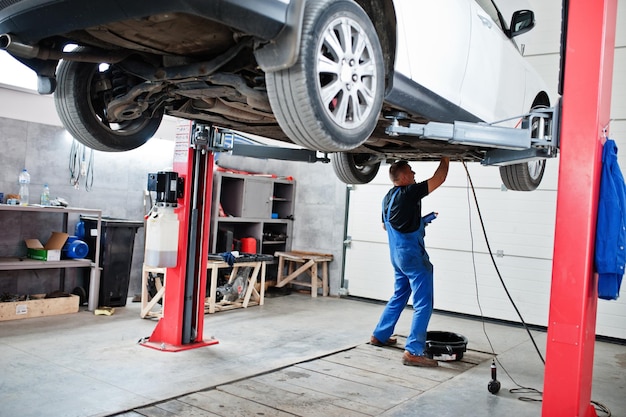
[373, 188, 433, 355]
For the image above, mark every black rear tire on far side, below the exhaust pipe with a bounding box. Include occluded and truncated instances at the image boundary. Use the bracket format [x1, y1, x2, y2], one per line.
[54, 56, 163, 152]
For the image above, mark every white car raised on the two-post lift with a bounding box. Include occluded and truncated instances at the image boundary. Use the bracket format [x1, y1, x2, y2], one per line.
[0, 0, 550, 190]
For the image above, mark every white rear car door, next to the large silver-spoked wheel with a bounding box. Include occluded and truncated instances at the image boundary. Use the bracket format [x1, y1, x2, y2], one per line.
[394, 0, 473, 105]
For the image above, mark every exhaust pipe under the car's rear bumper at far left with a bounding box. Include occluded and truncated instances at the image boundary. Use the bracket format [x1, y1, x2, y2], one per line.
[0, 33, 130, 64]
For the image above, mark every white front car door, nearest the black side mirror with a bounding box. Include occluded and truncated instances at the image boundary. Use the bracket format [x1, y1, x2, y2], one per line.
[461, 0, 530, 123]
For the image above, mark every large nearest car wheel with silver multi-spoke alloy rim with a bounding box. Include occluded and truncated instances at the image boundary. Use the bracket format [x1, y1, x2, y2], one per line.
[266, 0, 385, 152]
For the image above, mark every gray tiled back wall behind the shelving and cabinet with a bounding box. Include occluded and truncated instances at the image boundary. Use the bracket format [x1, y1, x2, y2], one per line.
[0, 118, 346, 302]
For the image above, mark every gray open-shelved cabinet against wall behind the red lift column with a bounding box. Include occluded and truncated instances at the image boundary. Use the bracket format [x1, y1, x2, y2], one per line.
[209, 171, 295, 255]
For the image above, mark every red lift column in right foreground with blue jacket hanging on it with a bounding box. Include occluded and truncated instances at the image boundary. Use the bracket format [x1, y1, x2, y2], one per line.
[542, 0, 617, 417]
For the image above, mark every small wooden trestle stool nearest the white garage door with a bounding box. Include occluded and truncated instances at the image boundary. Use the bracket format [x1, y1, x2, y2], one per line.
[274, 251, 333, 297]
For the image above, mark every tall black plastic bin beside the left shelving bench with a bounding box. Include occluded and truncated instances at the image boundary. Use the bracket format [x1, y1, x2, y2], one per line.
[80, 216, 143, 307]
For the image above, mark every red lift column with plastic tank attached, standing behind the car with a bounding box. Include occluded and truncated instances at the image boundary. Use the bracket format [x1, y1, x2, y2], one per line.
[143, 122, 218, 352]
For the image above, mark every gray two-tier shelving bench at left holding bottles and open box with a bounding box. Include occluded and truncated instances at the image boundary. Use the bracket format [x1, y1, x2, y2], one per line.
[0, 204, 102, 311]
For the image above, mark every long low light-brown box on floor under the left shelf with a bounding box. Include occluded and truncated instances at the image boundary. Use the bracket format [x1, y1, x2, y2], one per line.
[0, 294, 80, 321]
